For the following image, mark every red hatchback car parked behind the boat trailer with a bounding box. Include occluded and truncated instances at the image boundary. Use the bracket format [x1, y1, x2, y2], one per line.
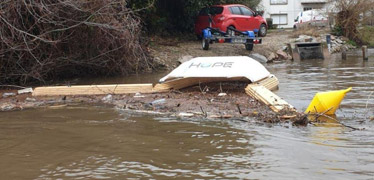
[195, 4, 268, 37]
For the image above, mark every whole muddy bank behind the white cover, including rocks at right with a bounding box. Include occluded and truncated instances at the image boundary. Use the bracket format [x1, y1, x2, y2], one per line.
[149, 28, 356, 70]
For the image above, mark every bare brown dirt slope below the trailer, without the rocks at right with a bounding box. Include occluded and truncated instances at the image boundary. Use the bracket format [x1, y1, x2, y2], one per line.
[150, 30, 295, 69]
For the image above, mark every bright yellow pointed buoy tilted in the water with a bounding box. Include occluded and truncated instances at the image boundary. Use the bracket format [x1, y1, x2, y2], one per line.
[305, 87, 352, 115]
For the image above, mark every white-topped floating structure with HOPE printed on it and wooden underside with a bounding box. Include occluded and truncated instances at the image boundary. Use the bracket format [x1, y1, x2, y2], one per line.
[154, 56, 279, 91]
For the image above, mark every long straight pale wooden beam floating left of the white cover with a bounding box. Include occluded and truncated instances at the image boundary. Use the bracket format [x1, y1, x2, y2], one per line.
[32, 84, 154, 96]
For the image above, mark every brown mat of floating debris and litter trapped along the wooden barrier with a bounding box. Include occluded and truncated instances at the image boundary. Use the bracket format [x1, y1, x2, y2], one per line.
[0, 82, 307, 124]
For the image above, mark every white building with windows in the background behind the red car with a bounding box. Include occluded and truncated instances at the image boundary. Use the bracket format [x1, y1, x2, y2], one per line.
[259, 0, 328, 28]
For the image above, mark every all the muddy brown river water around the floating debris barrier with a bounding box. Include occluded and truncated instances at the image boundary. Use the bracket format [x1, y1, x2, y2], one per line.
[0, 53, 374, 179]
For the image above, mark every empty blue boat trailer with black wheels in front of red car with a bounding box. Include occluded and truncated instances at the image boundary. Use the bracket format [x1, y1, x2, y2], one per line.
[202, 27, 262, 51]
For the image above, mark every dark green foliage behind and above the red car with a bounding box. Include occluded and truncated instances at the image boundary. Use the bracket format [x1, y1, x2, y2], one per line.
[129, 0, 260, 35]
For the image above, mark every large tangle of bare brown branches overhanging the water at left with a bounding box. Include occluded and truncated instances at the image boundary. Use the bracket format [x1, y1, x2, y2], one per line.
[0, 0, 152, 84]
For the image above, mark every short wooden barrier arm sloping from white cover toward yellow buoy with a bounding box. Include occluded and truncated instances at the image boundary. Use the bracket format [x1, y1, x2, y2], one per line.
[245, 85, 294, 112]
